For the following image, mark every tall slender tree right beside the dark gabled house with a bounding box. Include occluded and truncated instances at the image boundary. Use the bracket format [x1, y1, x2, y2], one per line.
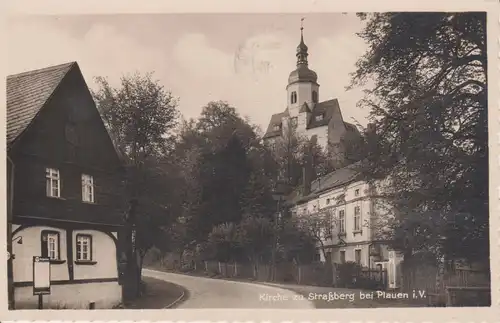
[93, 74, 178, 294]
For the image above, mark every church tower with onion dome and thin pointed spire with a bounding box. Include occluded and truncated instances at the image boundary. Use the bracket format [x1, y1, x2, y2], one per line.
[286, 19, 319, 130]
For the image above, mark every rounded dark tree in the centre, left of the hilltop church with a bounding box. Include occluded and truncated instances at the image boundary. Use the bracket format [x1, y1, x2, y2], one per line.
[170, 101, 274, 242]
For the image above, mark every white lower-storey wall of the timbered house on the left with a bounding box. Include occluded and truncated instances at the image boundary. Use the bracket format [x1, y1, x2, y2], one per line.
[12, 225, 122, 309]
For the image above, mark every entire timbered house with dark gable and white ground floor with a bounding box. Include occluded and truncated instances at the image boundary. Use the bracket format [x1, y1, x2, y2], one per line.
[7, 62, 126, 309]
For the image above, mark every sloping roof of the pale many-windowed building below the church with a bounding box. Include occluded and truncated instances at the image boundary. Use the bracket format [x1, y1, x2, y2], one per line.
[287, 163, 360, 205]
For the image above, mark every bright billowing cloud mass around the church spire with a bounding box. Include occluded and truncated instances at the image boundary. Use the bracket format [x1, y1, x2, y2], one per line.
[170, 27, 367, 128]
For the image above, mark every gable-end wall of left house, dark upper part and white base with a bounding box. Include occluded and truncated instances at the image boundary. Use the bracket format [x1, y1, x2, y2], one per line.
[8, 65, 127, 308]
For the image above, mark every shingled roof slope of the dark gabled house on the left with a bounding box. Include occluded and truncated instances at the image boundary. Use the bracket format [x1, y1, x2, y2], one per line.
[7, 62, 77, 147]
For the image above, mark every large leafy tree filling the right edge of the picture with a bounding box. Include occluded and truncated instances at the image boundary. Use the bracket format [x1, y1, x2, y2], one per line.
[351, 12, 489, 261]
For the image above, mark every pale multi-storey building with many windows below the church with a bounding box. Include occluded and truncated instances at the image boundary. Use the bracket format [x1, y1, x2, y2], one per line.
[287, 164, 399, 274]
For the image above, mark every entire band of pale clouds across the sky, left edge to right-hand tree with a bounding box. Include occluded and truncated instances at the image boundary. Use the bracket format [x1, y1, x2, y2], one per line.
[7, 15, 367, 133]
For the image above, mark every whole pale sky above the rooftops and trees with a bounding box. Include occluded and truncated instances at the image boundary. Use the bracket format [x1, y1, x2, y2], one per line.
[7, 13, 368, 133]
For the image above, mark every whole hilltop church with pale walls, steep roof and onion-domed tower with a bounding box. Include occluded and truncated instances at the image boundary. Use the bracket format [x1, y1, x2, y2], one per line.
[264, 27, 359, 161]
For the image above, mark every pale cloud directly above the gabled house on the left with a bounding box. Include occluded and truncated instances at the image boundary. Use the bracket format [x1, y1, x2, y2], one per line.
[8, 21, 164, 86]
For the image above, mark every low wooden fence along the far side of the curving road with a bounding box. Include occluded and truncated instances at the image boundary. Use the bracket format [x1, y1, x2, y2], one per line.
[145, 251, 491, 306]
